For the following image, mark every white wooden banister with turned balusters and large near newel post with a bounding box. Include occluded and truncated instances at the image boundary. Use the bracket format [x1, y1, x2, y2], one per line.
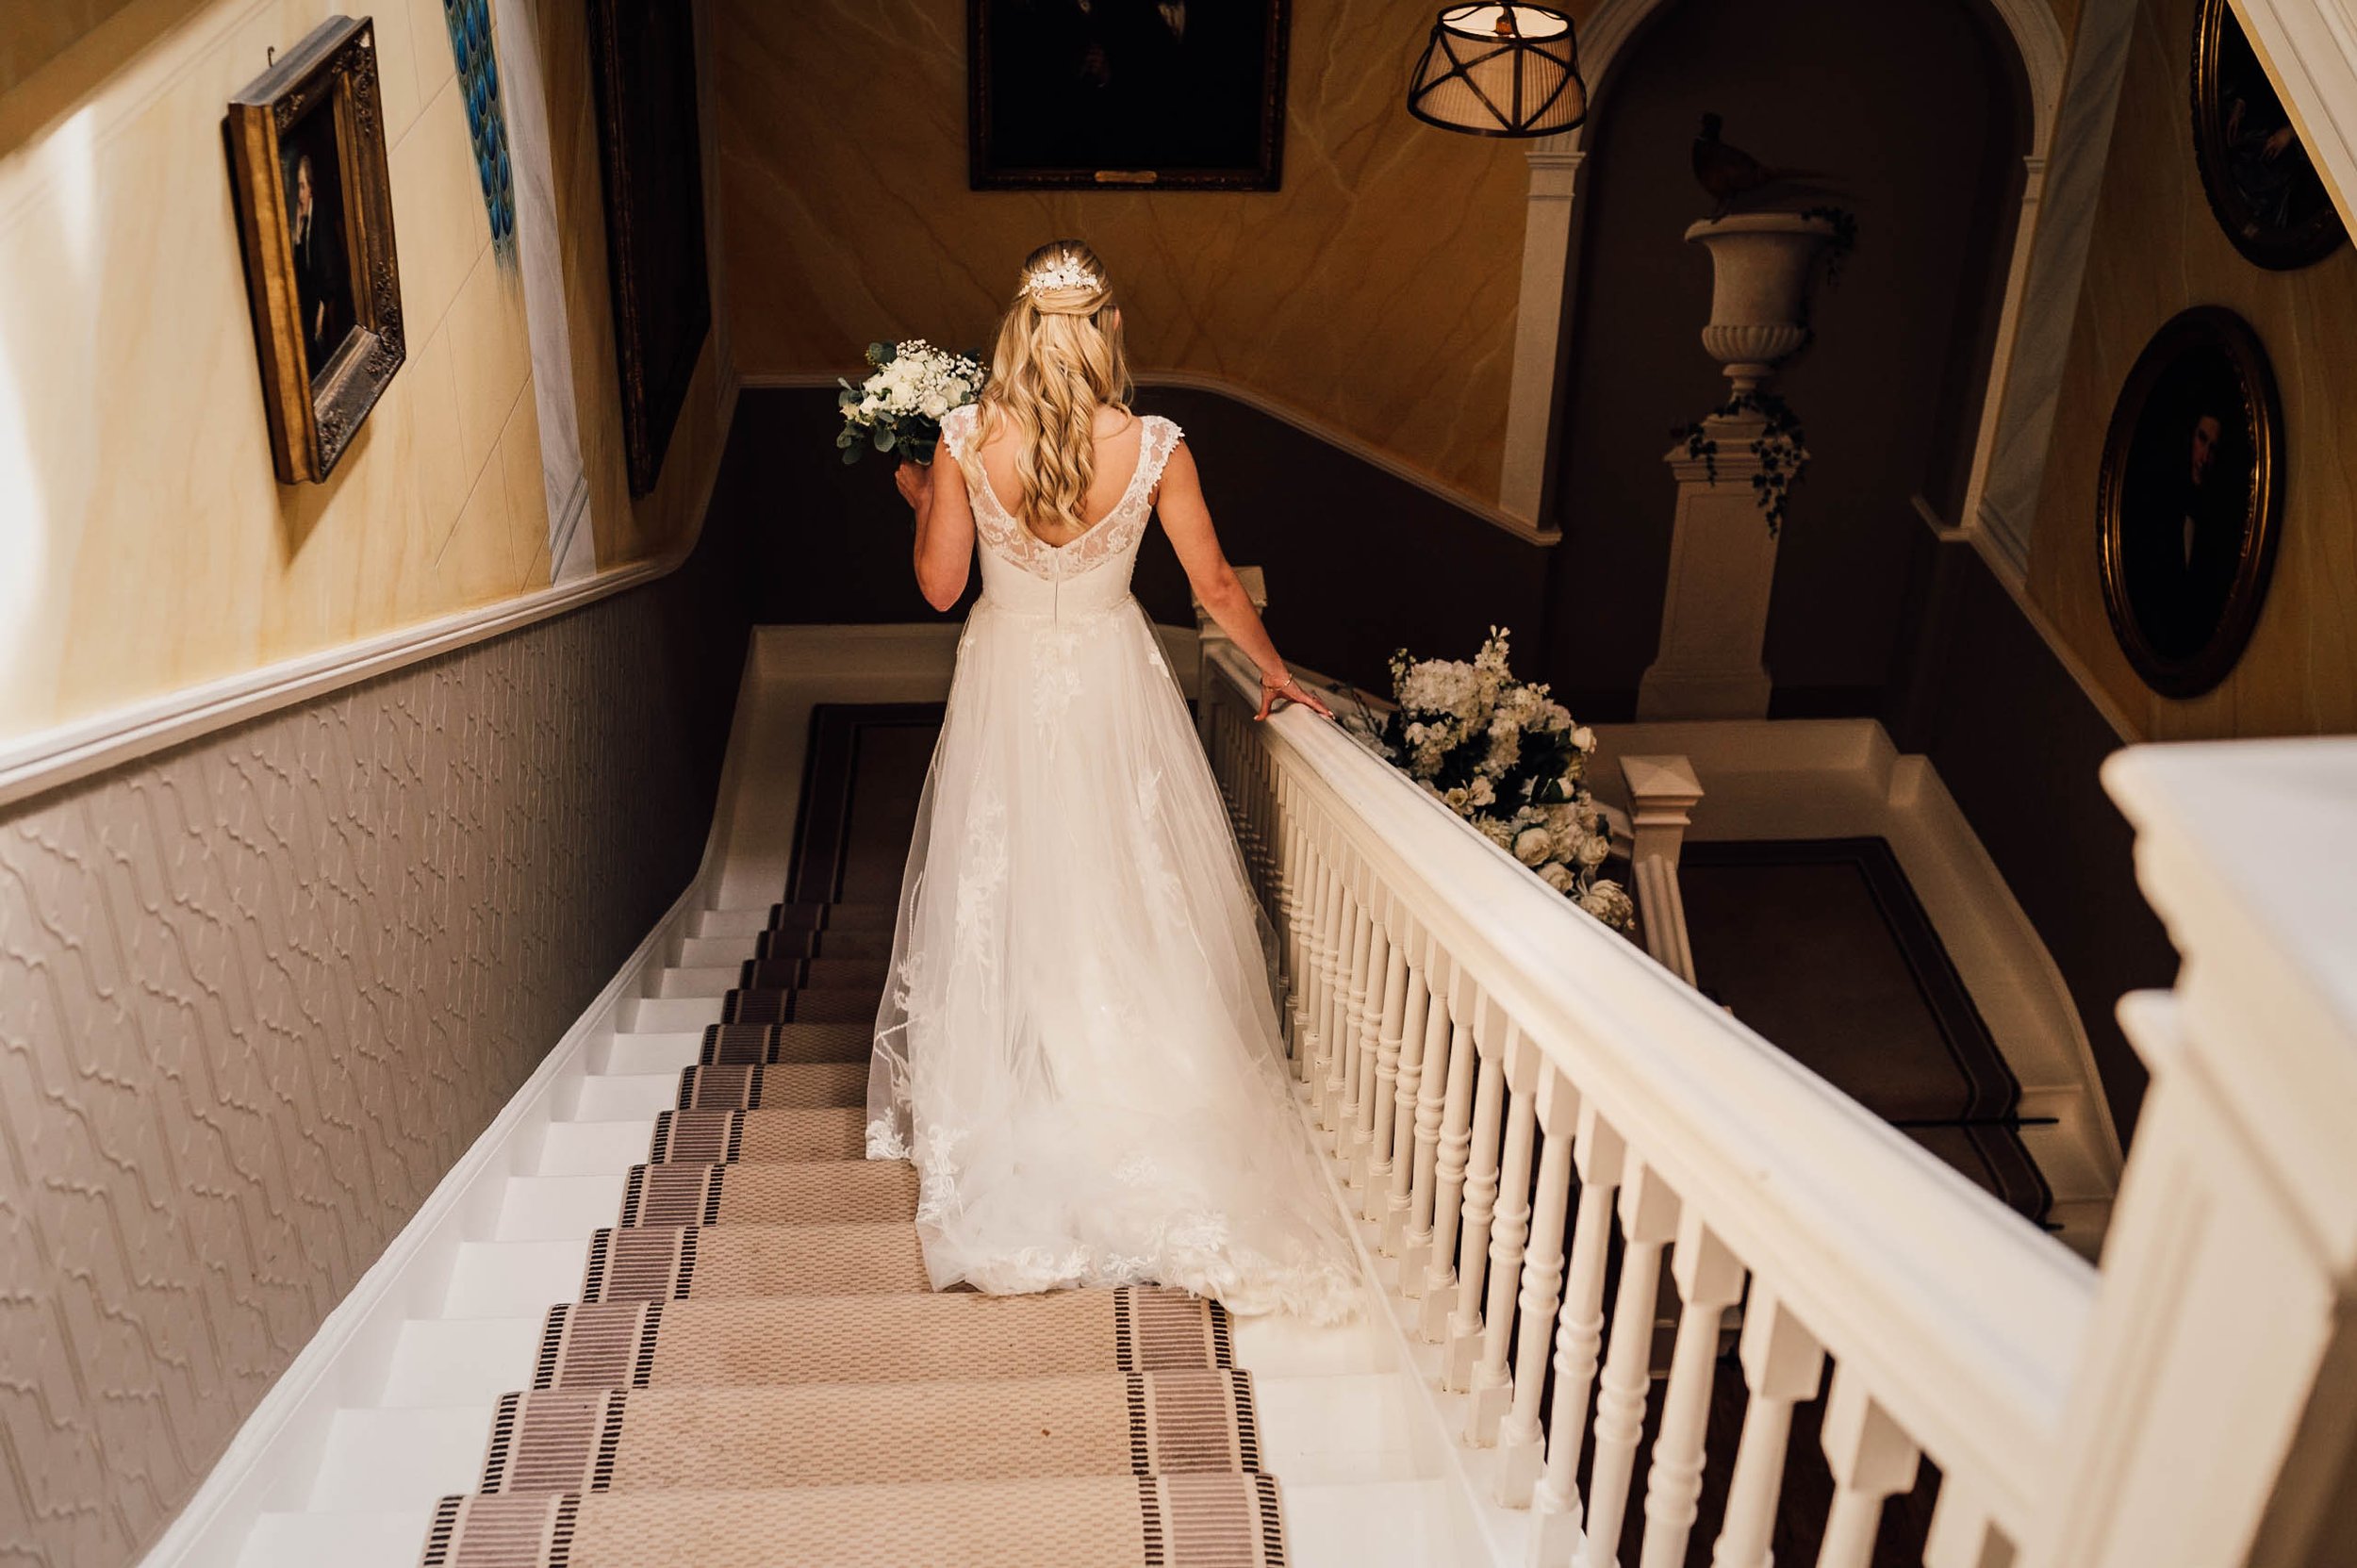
[1202, 636, 2357, 1568]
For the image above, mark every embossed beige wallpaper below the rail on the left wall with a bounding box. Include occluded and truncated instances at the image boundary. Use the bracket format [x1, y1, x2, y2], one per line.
[0, 537, 748, 1568]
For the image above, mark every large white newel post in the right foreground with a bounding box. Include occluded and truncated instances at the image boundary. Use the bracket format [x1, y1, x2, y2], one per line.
[2022, 740, 2357, 1568]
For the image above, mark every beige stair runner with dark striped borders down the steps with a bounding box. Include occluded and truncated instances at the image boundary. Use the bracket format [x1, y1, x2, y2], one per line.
[422, 707, 1285, 1568]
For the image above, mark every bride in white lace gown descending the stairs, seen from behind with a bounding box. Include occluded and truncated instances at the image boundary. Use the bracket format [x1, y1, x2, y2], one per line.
[867, 240, 1358, 1320]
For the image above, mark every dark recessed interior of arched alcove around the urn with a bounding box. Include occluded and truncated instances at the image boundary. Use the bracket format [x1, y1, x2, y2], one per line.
[1546, 0, 2046, 717]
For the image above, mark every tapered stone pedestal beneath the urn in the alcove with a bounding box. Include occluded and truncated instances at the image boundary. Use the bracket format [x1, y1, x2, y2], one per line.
[1636, 415, 1775, 719]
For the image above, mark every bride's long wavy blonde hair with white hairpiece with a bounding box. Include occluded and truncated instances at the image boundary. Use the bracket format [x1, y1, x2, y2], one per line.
[960, 240, 1131, 531]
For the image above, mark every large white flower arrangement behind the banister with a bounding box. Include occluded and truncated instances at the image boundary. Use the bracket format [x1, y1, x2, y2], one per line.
[1384, 627, 1636, 932]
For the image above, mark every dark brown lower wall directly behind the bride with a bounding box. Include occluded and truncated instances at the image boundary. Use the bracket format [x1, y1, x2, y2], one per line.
[715, 387, 1546, 691]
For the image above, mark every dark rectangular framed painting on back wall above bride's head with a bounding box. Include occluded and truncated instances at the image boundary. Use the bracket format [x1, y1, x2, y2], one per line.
[966, 0, 1287, 191]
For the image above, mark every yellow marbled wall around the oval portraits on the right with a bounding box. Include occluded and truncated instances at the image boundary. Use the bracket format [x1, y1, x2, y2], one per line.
[2030, 0, 2357, 740]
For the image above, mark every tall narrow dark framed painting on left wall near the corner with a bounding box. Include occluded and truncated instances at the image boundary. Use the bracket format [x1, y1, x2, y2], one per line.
[589, 0, 712, 495]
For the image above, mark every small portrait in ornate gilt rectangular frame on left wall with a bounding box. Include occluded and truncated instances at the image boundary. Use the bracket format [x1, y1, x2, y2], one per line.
[222, 17, 408, 484]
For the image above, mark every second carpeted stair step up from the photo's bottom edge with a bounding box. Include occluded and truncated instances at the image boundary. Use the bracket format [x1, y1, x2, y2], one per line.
[479, 1370, 1261, 1493]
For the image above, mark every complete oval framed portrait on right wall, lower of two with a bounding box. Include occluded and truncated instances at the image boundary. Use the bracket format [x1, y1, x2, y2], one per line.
[2096, 306, 2284, 698]
